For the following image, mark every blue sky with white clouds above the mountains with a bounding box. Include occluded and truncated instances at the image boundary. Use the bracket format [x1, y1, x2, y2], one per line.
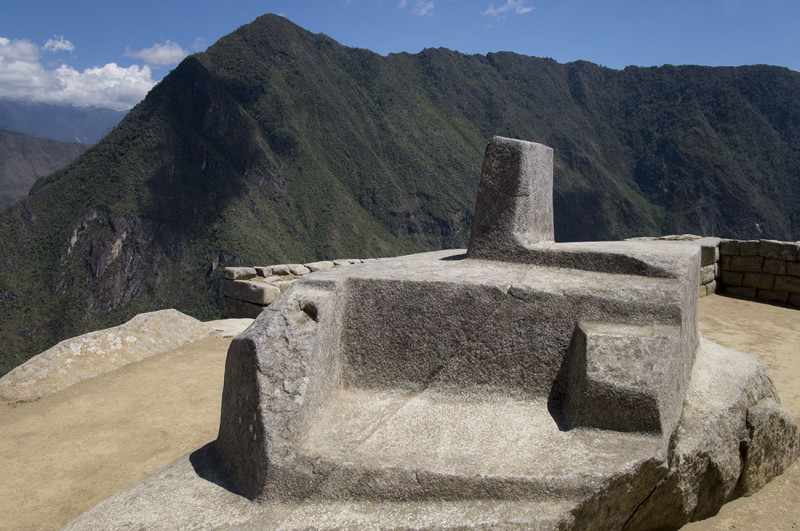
[0, 0, 800, 109]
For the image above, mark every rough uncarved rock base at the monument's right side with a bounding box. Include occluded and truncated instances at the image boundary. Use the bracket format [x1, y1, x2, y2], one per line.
[628, 340, 798, 529]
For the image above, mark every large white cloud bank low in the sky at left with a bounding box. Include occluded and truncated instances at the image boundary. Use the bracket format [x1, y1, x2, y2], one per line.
[0, 37, 155, 110]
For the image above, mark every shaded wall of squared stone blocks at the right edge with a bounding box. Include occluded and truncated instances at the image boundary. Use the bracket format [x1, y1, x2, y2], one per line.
[719, 240, 800, 306]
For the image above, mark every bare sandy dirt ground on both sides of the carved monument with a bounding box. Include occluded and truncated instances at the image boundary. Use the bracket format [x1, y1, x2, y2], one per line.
[0, 296, 800, 530]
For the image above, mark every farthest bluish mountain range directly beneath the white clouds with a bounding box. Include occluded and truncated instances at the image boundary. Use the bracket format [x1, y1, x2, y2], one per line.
[0, 99, 126, 144]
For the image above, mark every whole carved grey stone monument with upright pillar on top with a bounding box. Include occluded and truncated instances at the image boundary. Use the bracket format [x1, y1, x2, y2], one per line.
[69, 138, 798, 529]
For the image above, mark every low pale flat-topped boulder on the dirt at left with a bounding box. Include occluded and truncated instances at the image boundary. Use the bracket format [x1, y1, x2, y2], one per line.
[0, 310, 213, 401]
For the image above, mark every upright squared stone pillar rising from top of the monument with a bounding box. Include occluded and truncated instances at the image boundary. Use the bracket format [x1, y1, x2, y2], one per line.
[467, 136, 555, 260]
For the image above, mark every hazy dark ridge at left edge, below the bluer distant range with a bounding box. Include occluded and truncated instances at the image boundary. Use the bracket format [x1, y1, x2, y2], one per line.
[0, 130, 88, 210]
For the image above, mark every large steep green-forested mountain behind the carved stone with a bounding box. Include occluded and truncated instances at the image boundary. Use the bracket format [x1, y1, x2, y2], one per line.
[0, 15, 800, 373]
